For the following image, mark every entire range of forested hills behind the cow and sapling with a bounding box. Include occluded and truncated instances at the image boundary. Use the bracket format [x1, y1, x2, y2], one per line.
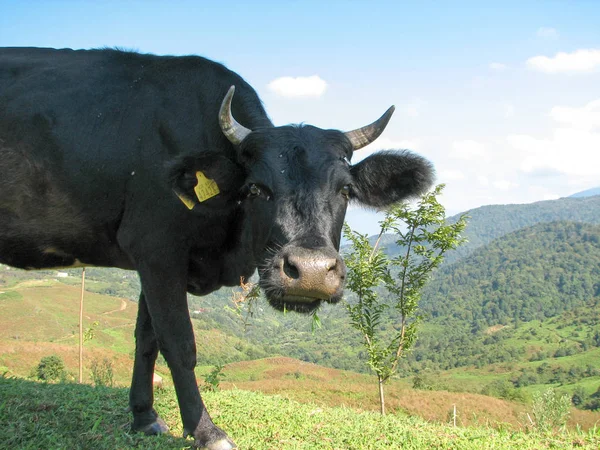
[0, 196, 600, 382]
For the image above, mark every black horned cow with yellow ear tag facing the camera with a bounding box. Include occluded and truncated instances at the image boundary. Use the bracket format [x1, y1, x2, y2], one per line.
[0, 48, 433, 450]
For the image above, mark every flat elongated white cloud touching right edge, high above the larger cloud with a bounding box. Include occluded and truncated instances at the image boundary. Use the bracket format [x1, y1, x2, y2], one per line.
[527, 49, 600, 73]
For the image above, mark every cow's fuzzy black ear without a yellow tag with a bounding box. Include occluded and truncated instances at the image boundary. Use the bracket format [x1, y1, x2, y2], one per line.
[350, 150, 434, 208]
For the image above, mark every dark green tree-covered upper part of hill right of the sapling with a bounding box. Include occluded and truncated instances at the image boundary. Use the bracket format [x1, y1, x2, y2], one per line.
[421, 222, 600, 330]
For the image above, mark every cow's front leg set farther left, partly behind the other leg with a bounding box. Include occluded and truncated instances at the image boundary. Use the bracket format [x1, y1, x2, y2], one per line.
[129, 292, 169, 434]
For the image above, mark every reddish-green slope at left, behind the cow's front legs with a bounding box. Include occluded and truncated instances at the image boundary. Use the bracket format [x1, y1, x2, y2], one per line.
[0, 278, 268, 383]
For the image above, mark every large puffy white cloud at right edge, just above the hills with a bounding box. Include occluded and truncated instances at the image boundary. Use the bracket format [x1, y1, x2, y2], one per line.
[507, 99, 600, 179]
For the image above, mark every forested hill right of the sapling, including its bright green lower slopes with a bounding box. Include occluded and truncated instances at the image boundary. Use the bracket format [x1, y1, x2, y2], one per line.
[408, 222, 600, 370]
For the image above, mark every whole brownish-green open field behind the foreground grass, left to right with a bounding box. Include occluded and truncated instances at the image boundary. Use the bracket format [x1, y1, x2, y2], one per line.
[0, 279, 600, 436]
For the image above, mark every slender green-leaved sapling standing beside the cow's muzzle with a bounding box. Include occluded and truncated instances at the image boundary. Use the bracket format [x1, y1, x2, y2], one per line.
[344, 185, 467, 414]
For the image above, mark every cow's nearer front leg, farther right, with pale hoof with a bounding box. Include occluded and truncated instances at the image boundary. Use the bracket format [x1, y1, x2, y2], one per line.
[138, 255, 235, 450]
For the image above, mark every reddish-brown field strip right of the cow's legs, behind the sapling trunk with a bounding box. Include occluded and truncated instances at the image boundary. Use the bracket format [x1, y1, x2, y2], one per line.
[211, 357, 600, 430]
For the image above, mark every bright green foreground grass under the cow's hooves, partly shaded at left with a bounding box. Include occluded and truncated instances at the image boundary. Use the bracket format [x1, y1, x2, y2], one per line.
[0, 377, 600, 450]
